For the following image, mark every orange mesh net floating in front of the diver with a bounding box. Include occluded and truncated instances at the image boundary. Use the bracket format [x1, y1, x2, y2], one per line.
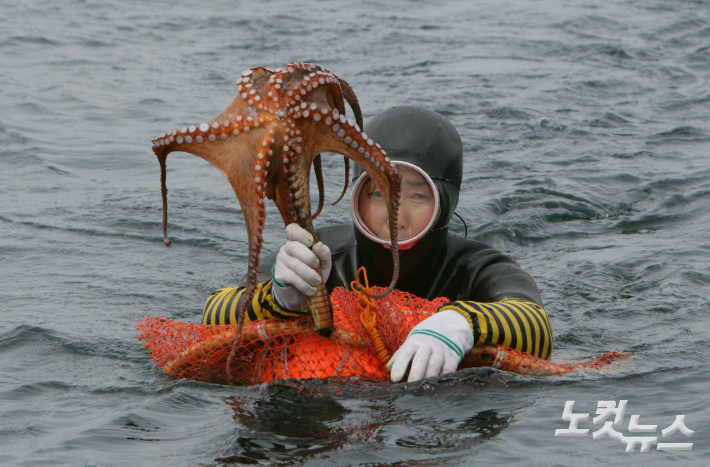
[136, 287, 629, 385]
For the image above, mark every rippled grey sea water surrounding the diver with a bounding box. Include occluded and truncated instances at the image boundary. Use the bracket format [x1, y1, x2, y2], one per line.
[0, 0, 710, 467]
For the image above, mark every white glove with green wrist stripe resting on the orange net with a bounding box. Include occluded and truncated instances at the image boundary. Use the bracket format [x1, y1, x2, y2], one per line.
[387, 310, 473, 383]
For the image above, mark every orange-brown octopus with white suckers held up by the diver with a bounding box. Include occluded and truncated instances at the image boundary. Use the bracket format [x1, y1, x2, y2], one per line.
[153, 63, 401, 352]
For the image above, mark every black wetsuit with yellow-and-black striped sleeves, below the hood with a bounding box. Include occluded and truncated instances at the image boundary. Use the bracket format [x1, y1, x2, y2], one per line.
[203, 224, 552, 358]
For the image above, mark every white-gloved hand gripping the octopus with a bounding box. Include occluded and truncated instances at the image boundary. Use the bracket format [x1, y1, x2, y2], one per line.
[271, 224, 332, 311]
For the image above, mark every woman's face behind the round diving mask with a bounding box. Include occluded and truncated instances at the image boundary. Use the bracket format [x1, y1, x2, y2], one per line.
[358, 166, 436, 240]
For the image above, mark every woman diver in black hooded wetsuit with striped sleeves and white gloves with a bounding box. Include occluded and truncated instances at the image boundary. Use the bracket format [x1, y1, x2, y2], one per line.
[203, 106, 552, 382]
